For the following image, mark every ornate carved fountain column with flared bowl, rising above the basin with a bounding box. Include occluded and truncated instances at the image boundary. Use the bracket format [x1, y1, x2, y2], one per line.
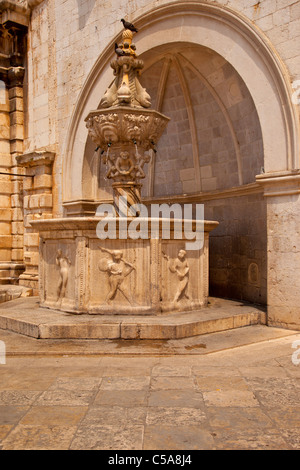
[86, 30, 169, 216]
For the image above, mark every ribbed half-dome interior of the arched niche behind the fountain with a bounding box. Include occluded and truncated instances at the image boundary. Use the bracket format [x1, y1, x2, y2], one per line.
[87, 42, 264, 201]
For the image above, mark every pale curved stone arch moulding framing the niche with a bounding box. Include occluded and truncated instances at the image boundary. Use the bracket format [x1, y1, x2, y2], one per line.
[62, 1, 299, 203]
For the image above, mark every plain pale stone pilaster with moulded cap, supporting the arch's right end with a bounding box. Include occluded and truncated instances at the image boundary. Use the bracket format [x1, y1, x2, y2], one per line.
[256, 170, 300, 330]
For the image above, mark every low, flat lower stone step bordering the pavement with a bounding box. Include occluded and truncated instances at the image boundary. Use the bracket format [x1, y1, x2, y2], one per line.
[0, 325, 299, 363]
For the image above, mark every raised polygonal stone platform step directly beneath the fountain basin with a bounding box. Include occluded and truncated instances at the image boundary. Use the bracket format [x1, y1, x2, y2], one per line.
[0, 297, 266, 340]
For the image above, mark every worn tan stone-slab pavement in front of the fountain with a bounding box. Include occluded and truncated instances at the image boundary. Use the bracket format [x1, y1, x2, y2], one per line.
[0, 327, 300, 451]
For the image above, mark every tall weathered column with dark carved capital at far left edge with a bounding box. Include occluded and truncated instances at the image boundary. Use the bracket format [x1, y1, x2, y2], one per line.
[0, 0, 30, 284]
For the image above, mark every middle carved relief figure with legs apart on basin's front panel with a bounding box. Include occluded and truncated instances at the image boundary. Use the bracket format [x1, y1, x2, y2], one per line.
[99, 247, 135, 304]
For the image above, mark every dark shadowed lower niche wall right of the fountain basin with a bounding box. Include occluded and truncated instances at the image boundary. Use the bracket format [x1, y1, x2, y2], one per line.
[204, 193, 267, 304]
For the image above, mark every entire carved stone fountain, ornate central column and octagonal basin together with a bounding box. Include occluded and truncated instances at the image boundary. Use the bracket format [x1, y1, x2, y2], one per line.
[33, 26, 218, 316]
